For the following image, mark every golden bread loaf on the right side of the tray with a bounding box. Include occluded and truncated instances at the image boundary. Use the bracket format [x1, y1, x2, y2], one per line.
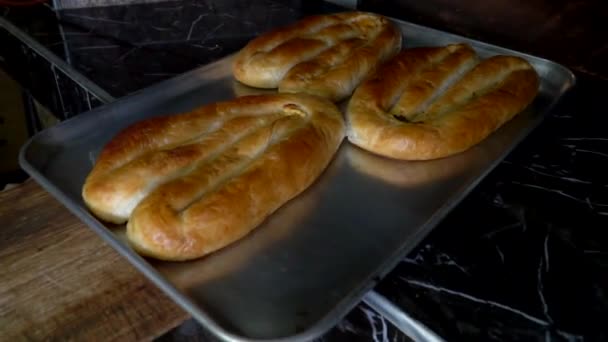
[346, 44, 539, 160]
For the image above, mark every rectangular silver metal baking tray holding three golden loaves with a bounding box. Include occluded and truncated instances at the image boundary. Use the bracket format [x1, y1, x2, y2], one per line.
[20, 14, 575, 341]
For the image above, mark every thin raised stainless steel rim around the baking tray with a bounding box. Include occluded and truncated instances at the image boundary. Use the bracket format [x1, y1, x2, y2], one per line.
[19, 12, 576, 341]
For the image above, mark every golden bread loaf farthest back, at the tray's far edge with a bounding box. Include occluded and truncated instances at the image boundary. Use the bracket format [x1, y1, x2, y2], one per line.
[233, 12, 401, 102]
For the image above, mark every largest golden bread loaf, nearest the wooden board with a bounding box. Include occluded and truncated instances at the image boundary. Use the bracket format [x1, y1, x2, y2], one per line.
[82, 94, 344, 260]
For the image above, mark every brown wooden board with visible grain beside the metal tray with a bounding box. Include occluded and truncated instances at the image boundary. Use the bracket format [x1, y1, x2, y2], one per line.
[0, 180, 188, 341]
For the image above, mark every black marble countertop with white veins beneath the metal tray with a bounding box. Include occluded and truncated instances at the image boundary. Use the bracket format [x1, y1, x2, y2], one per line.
[0, 0, 608, 341]
